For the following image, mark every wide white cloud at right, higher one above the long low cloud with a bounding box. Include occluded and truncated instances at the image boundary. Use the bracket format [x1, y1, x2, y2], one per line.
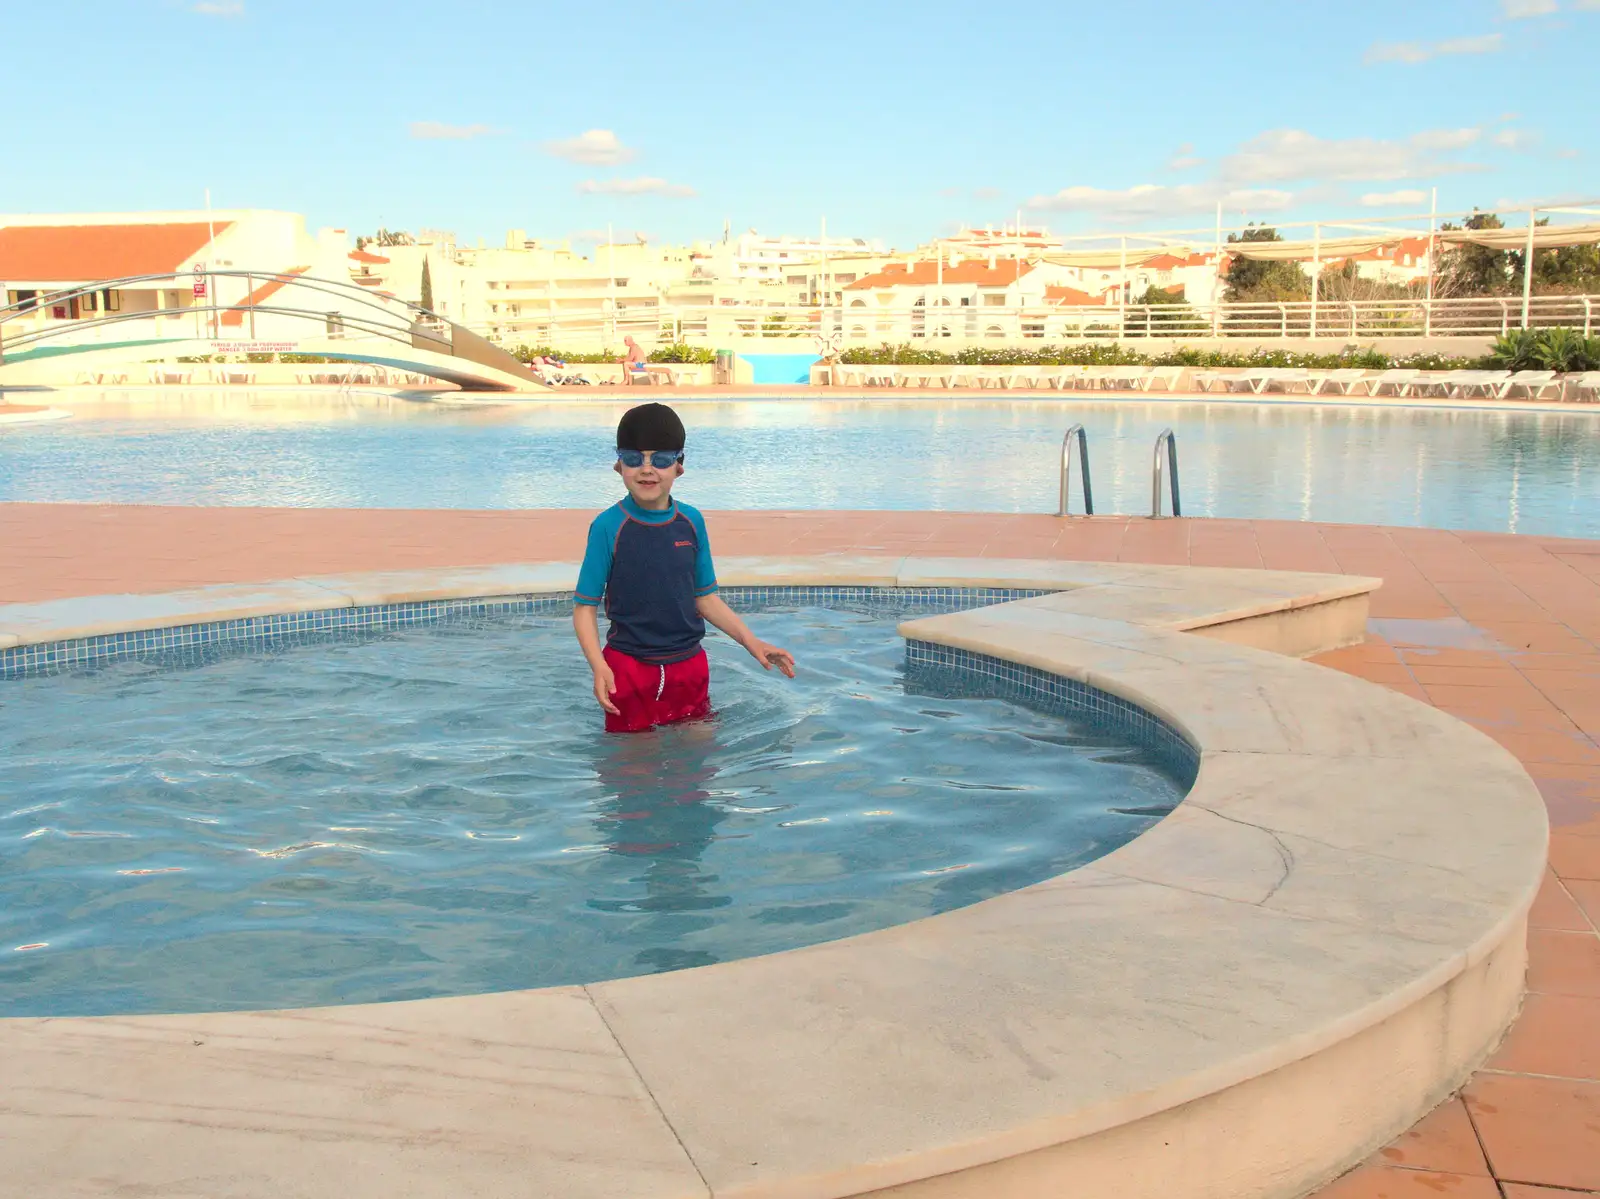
[1219, 130, 1480, 182]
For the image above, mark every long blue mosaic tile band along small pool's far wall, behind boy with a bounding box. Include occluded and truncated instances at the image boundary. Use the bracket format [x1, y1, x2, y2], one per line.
[0, 586, 1046, 680]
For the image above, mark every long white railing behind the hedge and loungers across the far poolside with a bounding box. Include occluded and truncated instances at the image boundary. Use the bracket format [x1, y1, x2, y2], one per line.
[467, 296, 1600, 352]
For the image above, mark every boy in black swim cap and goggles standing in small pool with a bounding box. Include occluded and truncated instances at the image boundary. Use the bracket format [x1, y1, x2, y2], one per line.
[573, 403, 795, 733]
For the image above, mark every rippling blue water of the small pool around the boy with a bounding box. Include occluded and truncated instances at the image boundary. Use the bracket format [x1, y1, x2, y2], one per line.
[0, 607, 1182, 1017]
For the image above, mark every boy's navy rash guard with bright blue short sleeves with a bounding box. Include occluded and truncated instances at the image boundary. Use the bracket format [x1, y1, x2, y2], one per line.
[574, 496, 717, 666]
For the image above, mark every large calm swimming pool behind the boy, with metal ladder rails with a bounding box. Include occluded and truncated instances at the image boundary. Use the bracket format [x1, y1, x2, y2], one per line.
[9, 392, 1600, 536]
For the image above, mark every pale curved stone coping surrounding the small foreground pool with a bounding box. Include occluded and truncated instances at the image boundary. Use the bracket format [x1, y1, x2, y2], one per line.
[0, 559, 1546, 1199]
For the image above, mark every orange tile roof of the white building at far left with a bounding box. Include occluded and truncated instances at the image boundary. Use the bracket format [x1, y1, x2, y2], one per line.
[0, 221, 232, 283]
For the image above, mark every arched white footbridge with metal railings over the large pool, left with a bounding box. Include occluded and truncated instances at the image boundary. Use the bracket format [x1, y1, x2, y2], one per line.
[0, 271, 547, 392]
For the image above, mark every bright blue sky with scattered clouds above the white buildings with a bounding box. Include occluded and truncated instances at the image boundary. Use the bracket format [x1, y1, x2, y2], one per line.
[0, 0, 1600, 248]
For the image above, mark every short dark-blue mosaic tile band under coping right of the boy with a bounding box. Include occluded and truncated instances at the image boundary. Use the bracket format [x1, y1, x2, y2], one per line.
[906, 640, 1200, 791]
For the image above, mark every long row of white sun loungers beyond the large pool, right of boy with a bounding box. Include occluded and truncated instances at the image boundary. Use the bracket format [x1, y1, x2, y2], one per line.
[834, 367, 1600, 400]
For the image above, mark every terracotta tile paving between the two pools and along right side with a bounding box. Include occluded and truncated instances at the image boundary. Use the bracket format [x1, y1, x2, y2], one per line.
[0, 504, 1600, 1199]
